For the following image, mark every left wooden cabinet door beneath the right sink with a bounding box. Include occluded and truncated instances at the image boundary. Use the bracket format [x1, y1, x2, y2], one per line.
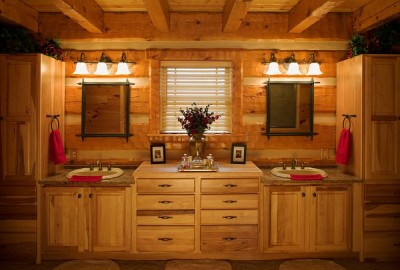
[264, 186, 307, 251]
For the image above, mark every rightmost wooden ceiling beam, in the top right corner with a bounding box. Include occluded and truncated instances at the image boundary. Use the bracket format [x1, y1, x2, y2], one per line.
[353, 0, 400, 33]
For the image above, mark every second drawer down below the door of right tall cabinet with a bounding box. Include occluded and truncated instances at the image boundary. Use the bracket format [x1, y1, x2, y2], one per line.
[364, 204, 400, 231]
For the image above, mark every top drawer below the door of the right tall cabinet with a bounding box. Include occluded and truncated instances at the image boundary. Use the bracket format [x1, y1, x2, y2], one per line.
[365, 184, 400, 203]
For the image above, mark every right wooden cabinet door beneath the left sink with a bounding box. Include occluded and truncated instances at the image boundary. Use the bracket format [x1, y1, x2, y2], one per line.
[87, 187, 131, 251]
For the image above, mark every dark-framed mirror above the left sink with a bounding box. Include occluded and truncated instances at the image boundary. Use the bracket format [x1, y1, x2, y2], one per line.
[79, 80, 134, 141]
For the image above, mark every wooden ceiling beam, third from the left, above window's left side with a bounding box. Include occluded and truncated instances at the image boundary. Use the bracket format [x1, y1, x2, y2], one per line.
[143, 0, 170, 32]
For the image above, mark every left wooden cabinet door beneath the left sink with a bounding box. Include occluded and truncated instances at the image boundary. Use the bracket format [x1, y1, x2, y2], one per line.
[42, 187, 88, 251]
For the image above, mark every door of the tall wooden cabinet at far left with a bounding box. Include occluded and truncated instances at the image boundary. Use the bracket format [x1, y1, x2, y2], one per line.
[0, 55, 37, 181]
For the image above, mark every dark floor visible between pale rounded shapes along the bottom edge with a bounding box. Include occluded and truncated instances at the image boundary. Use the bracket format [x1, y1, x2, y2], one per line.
[0, 259, 400, 270]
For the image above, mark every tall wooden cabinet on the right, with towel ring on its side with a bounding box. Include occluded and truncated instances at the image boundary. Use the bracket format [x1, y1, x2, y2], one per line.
[336, 55, 400, 260]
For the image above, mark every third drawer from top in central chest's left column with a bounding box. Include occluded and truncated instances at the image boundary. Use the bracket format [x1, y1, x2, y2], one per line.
[136, 210, 194, 225]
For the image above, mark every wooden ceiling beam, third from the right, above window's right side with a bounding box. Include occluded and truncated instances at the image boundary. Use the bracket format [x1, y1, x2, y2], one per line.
[222, 0, 252, 33]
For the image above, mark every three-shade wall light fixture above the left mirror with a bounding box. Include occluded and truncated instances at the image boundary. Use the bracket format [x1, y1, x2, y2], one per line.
[73, 52, 136, 75]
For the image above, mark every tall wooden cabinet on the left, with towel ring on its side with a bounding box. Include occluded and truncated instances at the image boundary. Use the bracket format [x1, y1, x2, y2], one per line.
[0, 54, 65, 260]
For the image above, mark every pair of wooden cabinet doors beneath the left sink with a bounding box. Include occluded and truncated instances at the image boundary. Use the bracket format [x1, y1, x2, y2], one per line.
[42, 186, 131, 255]
